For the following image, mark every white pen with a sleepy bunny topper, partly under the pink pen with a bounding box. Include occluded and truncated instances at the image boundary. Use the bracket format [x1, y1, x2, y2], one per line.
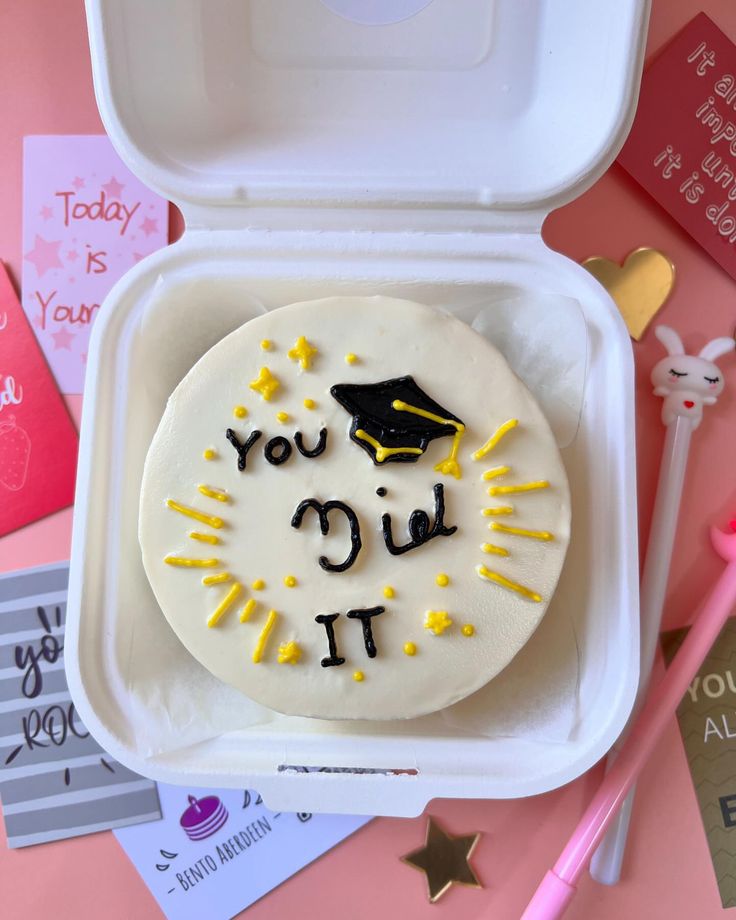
[590, 326, 734, 885]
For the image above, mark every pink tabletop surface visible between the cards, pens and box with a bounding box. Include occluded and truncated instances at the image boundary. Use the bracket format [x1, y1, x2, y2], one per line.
[0, 0, 736, 920]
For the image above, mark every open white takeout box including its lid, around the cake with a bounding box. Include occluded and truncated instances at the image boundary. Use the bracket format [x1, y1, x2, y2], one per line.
[66, 0, 648, 815]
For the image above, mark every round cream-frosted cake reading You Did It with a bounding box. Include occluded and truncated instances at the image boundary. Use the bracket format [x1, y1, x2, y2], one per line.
[139, 297, 570, 719]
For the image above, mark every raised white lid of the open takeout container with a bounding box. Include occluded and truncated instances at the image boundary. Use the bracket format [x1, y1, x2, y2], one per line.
[87, 0, 649, 221]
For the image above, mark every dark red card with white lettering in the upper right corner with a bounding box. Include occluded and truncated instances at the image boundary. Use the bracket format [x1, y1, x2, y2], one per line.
[619, 13, 736, 278]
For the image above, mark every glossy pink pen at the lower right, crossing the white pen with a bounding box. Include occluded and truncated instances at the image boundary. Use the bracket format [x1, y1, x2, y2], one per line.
[522, 520, 736, 920]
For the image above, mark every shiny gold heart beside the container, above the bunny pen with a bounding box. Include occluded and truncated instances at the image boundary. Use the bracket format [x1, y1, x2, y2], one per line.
[582, 246, 675, 342]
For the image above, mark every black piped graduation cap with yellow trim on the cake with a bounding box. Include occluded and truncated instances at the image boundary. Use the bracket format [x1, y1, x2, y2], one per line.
[330, 377, 465, 465]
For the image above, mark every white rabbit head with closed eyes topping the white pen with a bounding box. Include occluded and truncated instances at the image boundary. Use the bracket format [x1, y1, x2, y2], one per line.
[652, 326, 736, 397]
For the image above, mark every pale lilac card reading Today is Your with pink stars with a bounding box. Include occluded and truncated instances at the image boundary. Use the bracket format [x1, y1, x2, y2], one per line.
[22, 135, 168, 393]
